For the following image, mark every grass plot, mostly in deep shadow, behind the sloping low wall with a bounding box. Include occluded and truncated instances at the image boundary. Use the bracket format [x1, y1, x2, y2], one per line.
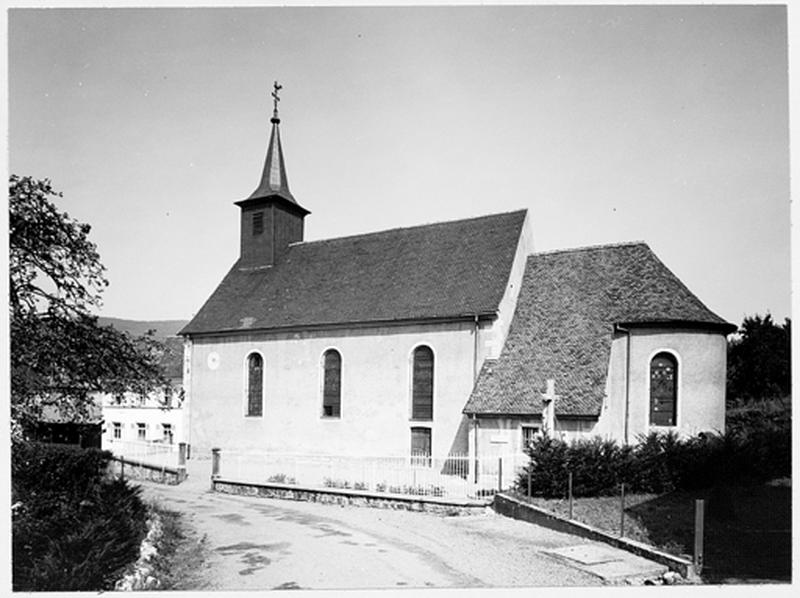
[521, 486, 792, 583]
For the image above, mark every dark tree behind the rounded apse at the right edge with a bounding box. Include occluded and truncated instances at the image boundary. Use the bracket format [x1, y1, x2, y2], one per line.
[728, 314, 792, 401]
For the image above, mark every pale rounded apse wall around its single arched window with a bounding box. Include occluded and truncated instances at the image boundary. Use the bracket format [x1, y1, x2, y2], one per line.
[594, 329, 727, 442]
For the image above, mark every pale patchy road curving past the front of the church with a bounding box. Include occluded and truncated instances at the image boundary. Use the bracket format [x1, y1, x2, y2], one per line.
[136, 462, 600, 590]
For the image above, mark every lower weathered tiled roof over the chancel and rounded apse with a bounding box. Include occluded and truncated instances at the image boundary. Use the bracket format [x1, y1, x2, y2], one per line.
[464, 243, 735, 417]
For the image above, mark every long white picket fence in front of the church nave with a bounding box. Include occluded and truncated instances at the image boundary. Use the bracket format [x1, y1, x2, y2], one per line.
[215, 450, 528, 498]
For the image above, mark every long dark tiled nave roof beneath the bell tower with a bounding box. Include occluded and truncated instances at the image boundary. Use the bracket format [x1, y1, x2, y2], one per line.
[180, 210, 526, 335]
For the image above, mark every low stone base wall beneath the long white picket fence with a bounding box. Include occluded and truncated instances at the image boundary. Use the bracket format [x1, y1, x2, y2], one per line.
[211, 478, 490, 516]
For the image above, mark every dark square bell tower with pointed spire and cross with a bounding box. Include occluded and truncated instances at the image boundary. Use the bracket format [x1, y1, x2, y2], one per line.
[236, 81, 311, 268]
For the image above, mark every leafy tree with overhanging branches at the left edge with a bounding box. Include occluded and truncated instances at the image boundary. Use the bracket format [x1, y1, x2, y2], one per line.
[9, 175, 169, 434]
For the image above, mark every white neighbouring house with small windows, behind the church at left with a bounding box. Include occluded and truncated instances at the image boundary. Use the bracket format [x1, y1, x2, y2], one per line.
[99, 336, 185, 449]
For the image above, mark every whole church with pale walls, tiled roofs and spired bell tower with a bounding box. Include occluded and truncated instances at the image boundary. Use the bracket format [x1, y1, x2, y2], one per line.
[180, 86, 735, 466]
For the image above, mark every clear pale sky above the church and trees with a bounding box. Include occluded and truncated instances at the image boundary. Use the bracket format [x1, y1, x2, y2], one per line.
[7, 5, 790, 324]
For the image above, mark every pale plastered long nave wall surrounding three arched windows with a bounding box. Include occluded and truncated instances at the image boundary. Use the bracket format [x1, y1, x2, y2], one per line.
[184, 321, 476, 456]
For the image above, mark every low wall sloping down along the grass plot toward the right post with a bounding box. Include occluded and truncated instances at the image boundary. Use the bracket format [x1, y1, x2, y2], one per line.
[493, 494, 699, 580]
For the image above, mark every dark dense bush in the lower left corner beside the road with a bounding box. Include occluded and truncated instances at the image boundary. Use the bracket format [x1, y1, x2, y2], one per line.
[11, 442, 147, 591]
